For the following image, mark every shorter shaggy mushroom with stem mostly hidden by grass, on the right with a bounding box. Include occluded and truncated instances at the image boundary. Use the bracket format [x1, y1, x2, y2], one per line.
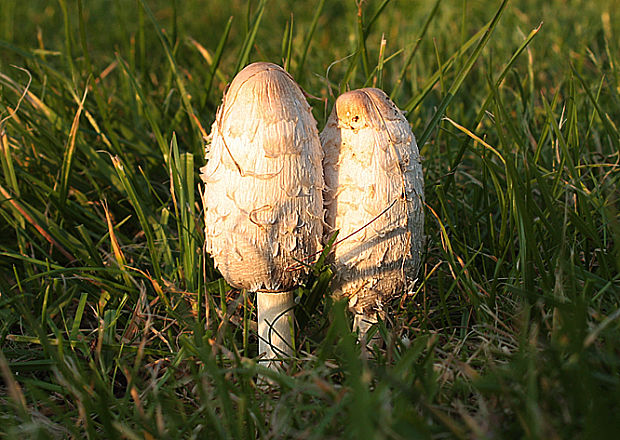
[321, 88, 424, 347]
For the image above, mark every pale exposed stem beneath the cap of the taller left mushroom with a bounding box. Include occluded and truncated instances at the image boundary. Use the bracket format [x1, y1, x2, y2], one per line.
[256, 291, 295, 368]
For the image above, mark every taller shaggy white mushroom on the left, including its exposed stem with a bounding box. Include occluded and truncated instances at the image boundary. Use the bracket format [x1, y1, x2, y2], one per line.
[201, 63, 324, 366]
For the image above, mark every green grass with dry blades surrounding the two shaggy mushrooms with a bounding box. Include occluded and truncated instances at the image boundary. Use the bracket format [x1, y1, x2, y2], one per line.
[0, 0, 620, 439]
